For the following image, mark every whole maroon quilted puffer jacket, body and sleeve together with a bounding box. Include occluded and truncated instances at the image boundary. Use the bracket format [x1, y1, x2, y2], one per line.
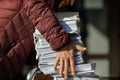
[0, 0, 69, 80]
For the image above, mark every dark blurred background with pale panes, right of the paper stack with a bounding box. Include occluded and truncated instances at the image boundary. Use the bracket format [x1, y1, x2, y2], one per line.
[56, 0, 120, 77]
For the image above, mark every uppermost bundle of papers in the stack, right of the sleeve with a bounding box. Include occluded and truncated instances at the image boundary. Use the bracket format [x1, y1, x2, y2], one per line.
[55, 12, 80, 33]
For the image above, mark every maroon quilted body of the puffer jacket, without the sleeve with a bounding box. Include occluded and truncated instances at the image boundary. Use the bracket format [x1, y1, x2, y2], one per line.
[0, 0, 34, 80]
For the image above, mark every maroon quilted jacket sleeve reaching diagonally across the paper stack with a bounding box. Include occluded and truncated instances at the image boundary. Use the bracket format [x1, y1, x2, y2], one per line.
[24, 0, 69, 50]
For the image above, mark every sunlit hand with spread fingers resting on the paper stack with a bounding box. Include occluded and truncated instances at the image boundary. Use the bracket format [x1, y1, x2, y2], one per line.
[54, 43, 86, 78]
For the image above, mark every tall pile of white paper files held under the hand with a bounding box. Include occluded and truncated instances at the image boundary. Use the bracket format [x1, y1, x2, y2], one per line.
[33, 12, 99, 80]
